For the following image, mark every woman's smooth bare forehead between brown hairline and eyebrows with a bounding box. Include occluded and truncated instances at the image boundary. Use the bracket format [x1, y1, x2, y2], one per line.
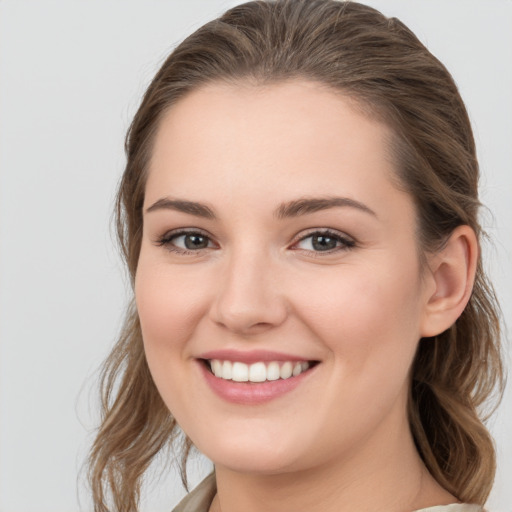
[146, 81, 410, 222]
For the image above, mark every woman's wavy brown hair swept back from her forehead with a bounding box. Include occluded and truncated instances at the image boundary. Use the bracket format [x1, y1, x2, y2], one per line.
[89, 0, 503, 512]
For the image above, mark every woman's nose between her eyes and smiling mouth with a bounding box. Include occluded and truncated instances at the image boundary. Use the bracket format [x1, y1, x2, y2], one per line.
[210, 246, 288, 335]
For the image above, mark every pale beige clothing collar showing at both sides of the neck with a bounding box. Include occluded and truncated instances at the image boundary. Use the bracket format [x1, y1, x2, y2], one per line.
[172, 473, 485, 512]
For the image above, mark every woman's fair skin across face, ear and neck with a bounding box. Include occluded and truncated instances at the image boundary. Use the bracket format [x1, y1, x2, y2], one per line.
[135, 81, 477, 512]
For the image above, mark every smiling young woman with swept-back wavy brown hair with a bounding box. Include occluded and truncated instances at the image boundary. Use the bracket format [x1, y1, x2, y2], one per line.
[90, 0, 502, 512]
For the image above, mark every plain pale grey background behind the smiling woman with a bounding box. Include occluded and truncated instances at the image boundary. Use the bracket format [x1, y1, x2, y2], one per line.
[0, 0, 512, 512]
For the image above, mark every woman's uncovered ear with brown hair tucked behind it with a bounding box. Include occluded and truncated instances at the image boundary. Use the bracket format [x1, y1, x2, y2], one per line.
[421, 225, 478, 337]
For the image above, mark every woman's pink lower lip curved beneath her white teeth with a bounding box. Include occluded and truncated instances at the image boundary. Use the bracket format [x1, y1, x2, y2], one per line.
[198, 361, 317, 405]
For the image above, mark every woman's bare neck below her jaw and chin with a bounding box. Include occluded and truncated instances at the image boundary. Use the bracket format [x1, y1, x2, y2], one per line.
[210, 410, 456, 512]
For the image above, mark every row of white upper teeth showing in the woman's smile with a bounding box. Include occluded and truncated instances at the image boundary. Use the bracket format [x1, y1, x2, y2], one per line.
[210, 359, 310, 382]
